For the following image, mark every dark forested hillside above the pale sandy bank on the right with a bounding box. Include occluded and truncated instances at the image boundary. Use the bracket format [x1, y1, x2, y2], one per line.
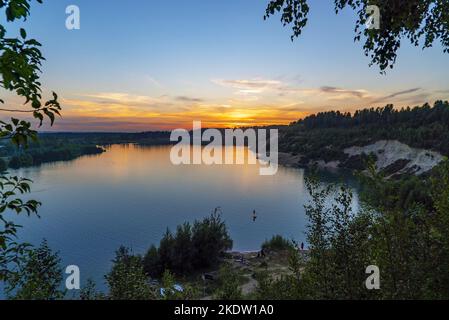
[279, 101, 449, 163]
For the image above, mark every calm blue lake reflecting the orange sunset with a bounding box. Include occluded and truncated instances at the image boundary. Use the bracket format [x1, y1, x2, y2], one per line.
[9, 145, 356, 288]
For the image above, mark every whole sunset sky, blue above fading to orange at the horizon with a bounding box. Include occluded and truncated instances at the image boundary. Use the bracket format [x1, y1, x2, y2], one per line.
[0, 0, 449, 131]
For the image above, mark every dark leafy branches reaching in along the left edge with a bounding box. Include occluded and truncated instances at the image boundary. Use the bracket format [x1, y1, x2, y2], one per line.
[0, 0, 61, 280]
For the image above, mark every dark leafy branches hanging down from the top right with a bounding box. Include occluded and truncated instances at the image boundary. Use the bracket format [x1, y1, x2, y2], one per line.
[265, 0, 449, 72]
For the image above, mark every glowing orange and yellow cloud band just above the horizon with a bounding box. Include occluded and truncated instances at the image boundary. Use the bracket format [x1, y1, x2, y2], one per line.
[0, 79, 434, 131]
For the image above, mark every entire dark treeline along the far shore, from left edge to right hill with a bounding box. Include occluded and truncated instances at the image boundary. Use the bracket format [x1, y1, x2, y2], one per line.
[0, 101, 449, 170]
